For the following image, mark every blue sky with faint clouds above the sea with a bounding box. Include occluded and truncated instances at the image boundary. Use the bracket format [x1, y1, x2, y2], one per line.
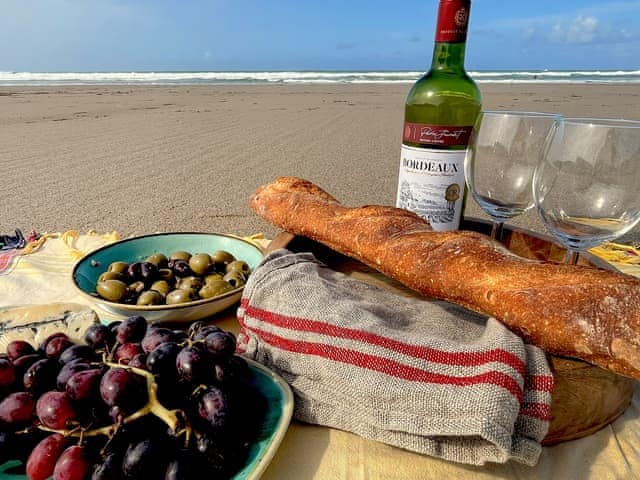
[0, 0, 640, 71]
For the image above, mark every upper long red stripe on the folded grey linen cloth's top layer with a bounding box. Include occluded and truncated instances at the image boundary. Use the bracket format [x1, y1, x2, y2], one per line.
[238, 298, 526, 378]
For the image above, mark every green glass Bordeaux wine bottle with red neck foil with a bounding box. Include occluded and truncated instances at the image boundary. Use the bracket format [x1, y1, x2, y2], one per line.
[396, 0, 481, 231]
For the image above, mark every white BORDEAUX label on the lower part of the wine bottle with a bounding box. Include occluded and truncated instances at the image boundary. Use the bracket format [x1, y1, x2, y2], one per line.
[396, 145, 465, 231]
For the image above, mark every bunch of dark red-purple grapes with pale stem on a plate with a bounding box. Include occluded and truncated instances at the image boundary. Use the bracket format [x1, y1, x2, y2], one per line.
[0, 316, 265, 480]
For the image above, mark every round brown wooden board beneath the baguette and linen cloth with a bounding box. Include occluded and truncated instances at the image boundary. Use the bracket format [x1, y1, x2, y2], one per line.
[268, 219, 635, 445]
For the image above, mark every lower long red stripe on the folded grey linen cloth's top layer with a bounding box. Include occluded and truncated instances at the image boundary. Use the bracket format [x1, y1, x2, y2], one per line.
[245, 325, 523, 403]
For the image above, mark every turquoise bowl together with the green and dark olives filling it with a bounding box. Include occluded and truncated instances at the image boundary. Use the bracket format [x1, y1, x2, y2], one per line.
[72, 232, 264, 322]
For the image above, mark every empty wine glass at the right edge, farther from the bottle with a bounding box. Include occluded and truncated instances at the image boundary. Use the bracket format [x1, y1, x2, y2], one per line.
[533, 118, 640, 264]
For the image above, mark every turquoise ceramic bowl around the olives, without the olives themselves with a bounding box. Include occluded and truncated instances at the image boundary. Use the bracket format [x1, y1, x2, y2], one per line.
[72, 232, 264, 322]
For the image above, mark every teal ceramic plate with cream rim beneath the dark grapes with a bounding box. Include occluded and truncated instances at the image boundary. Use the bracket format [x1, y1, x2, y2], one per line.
[0, 360, 293, 480]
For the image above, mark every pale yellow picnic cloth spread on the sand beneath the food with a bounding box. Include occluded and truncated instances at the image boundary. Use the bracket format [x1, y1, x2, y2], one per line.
[0, 231, 640, 480]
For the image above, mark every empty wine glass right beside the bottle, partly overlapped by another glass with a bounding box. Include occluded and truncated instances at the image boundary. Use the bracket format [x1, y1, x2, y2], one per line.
[465, 111, 560, 240]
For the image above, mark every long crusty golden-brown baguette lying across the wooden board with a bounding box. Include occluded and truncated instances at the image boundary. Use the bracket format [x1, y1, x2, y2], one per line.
[249, 177, 640, 379]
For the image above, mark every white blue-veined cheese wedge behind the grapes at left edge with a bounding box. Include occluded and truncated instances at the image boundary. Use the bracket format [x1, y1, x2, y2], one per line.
[0, 303, 100, 352]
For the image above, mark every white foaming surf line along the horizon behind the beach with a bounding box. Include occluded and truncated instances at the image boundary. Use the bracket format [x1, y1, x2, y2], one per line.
[0, 70, 640, 86]
